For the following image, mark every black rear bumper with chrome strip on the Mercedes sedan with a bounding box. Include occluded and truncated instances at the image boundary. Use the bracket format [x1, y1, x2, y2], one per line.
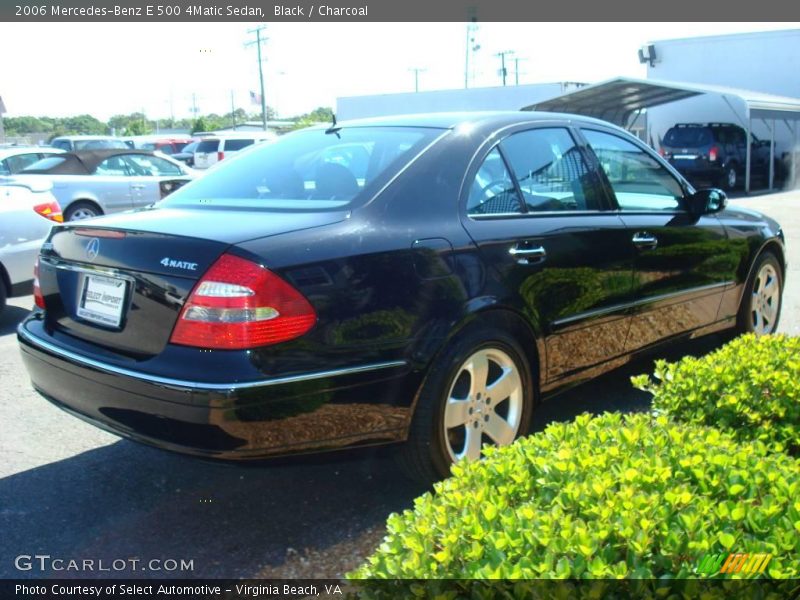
[17, 317, 418, 459]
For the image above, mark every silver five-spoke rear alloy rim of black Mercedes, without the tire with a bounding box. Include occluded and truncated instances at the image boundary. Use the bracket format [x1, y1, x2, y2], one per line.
[444, 348, 523, 461]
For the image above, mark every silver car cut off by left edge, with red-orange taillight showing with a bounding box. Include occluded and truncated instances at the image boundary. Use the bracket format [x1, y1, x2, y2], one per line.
[0, 177, 62, 310]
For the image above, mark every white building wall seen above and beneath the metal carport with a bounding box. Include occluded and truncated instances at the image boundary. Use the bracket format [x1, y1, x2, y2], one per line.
[647, 29, 800, 155]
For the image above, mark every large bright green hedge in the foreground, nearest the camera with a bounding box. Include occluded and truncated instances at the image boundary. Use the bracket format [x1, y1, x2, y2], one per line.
[349, 413, 800, 580]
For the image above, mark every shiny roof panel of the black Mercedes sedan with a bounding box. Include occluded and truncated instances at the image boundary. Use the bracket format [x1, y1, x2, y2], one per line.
[318, 111, 618, 129]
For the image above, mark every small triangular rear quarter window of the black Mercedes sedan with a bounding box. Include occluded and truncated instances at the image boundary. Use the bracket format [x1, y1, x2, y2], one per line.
[467, 148, 522, 216]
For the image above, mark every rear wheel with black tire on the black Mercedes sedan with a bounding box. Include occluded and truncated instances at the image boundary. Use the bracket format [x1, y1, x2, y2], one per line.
[397, 326, 535, 484]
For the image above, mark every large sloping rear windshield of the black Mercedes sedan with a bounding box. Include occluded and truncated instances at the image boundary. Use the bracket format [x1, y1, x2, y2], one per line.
[166, 127, 442, 210]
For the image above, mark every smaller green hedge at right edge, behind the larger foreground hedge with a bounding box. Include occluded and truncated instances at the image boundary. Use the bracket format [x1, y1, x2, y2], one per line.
[632, 335, 800, 455]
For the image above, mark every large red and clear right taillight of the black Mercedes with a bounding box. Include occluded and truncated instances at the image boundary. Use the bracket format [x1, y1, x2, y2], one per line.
[170, 254, 317, 350]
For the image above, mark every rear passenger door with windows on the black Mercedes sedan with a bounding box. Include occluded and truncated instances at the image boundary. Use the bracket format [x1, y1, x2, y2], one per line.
[462, 123, 633, 381]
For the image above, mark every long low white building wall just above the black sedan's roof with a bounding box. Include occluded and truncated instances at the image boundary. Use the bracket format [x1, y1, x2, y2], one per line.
[336, 83, 580, 120]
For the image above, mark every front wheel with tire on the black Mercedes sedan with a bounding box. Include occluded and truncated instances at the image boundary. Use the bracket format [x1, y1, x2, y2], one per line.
[737, 251, 783, 336]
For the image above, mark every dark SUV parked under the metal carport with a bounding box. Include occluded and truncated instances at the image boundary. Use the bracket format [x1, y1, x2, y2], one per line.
[661, 123, 769, 190]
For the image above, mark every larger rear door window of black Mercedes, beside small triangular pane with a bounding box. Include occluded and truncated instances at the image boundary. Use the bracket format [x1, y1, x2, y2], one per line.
[500, 128, 602, 212]
